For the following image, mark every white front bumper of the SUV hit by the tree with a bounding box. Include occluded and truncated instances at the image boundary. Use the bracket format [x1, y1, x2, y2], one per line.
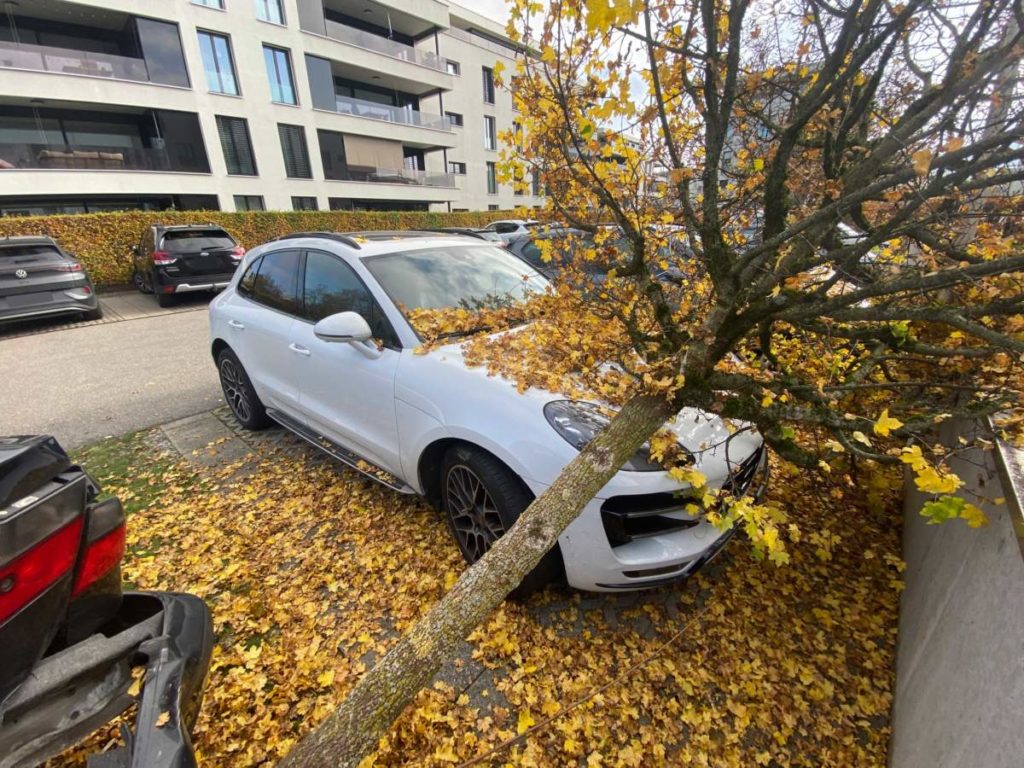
[534, 451, 768, 592]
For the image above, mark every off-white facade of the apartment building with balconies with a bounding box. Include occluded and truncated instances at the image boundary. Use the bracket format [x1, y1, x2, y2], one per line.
[0, 0, 543, 214]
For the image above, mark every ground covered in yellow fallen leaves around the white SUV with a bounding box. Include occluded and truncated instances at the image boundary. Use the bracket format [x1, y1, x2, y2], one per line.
[54, 436, 900, 768]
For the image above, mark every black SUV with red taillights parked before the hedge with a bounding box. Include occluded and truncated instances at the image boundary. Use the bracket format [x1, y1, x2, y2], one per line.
[132, 224, 246, 307]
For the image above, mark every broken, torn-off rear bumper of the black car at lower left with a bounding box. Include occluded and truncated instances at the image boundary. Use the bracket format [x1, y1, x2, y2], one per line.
[0, 592, 213, 768]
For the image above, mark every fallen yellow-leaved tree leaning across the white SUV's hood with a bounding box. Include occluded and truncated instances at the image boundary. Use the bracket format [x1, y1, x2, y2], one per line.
[282, 0, 1024, 766]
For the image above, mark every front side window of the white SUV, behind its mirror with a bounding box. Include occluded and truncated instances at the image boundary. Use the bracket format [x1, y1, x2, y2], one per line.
[302, 251, 398, 346]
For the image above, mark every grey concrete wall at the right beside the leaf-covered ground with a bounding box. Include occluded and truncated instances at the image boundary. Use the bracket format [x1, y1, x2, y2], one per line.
[890, 425, 1024, 768]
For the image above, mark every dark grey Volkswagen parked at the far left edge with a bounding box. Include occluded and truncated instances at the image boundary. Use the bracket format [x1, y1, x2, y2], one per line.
[0, 237, 103, 321]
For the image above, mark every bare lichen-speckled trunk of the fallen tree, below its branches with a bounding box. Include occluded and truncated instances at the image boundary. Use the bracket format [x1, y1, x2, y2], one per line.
[280, 395, 672, 768]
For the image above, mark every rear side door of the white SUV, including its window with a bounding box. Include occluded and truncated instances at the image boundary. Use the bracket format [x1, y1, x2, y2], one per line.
[222, 249, 302, 419]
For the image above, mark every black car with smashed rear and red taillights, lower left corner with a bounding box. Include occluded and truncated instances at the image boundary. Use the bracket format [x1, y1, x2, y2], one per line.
[0, 436, 213, 768]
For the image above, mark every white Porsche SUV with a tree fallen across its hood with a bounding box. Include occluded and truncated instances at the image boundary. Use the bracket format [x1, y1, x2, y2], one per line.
[210, 232, 767, 593]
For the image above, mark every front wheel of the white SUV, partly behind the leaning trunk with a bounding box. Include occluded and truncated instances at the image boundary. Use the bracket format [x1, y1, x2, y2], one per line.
[441, 445, 565, 599]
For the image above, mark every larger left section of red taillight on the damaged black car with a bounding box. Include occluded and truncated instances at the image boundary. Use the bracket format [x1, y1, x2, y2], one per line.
[0, 517, 82, 624]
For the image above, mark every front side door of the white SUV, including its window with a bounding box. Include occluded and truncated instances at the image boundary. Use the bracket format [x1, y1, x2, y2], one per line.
[292, 251, 401, 475]
